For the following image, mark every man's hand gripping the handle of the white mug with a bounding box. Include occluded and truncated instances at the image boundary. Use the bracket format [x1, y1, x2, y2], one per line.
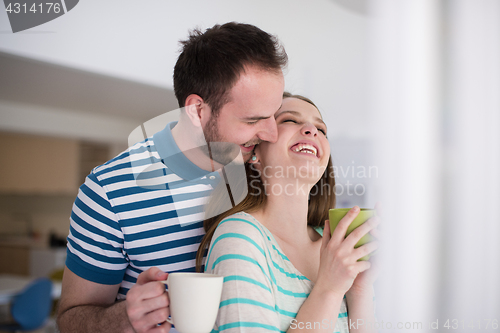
[126, 267, 171, 333]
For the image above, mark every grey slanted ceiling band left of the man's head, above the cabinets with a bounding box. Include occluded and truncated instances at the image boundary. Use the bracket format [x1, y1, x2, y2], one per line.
[0, 52, 178, 122]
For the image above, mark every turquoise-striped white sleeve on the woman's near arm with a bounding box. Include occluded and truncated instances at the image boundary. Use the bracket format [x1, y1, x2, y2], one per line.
[205, 217, 280, 333]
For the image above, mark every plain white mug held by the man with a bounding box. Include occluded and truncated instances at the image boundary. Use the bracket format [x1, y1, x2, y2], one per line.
[163, 273, 224, 333]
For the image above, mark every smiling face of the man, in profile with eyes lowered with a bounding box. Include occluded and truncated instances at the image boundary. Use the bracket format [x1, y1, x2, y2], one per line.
[202, 66, 285, 163]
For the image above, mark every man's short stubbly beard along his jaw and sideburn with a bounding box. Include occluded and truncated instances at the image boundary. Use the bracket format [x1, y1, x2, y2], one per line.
[200, 116, 240, 165]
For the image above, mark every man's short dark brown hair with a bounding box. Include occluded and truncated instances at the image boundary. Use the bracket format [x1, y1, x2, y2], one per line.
[174, 22, 288, 116]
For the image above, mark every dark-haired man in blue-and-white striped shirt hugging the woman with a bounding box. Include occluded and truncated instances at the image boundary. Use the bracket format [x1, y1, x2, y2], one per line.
[58, 23, 287, 333]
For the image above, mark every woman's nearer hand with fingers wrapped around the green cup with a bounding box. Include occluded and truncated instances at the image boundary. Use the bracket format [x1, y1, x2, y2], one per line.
[315, 206, 379, 296]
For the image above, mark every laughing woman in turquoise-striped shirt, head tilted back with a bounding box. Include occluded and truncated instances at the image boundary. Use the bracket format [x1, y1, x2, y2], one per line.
[198, 93, 378, 332]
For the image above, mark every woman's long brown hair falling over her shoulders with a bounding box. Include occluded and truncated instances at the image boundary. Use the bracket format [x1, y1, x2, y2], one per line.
[196, 92, 335, 272]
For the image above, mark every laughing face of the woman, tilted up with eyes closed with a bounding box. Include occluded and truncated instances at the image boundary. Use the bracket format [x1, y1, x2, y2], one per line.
[255, 97, 330, 183]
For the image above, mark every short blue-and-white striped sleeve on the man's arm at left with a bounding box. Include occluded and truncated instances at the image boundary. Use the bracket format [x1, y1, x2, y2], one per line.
[66, 172, 128, 285]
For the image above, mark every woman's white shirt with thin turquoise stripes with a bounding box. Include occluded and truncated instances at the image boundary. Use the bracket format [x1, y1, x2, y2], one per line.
[205, 213, 349, 333]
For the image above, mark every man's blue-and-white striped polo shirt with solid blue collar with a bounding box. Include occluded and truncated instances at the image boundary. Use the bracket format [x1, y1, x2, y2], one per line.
[66, 122, 225, 299]
